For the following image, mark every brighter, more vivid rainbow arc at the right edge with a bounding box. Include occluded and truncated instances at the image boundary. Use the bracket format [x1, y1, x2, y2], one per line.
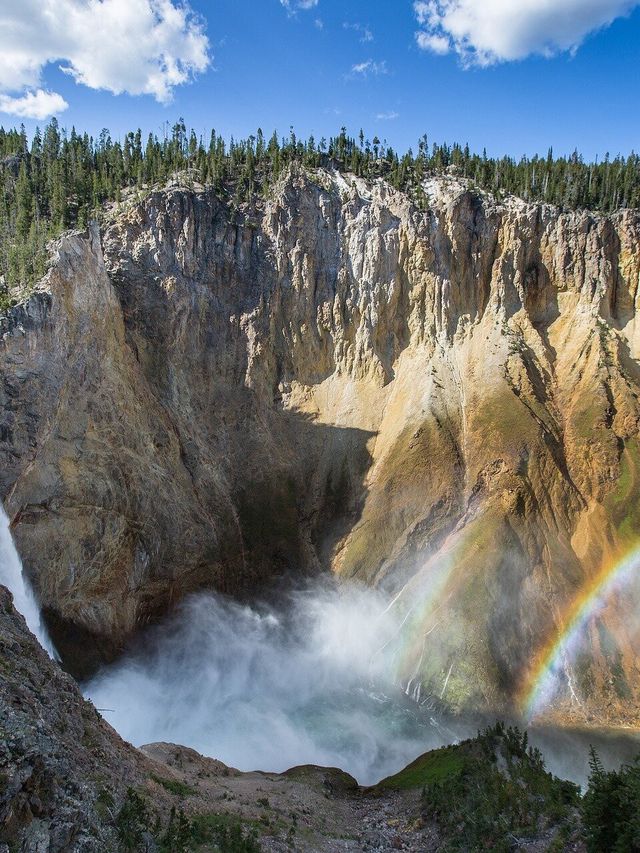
[521, 545, 640, 720]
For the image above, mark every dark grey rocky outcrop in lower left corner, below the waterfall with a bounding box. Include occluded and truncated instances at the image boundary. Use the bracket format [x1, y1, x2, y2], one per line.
[0, 586, 151, 853]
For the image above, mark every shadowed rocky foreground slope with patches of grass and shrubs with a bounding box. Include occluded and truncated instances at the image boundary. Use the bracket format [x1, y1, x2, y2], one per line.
[0, 587, 596, 853]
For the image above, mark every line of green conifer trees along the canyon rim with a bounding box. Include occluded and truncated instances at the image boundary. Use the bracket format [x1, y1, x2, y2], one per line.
[0, 118, 640, 308]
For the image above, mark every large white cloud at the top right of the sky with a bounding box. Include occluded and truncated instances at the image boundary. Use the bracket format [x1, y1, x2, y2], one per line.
[413, 0, 640, 66]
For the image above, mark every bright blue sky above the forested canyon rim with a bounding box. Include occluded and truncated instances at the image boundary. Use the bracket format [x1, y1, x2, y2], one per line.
[0, 0, 640, 158]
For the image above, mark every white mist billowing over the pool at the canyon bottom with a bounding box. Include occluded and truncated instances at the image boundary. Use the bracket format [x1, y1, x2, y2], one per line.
[86, 586, 462, 783]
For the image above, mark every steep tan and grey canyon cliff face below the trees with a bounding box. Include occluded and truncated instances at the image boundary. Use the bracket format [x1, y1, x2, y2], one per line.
[0, 171, 640, 719]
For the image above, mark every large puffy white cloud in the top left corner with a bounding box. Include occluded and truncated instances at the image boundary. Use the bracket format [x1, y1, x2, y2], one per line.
[0, 0, 209, 117]
